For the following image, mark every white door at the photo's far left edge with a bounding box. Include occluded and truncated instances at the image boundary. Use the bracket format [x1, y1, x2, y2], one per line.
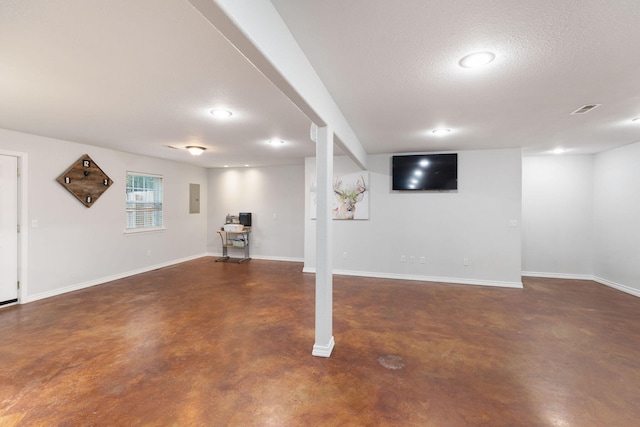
[0, 155, 18, 305]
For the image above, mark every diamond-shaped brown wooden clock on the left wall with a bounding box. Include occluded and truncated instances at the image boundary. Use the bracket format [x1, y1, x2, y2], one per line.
[56, 154, 113, 208]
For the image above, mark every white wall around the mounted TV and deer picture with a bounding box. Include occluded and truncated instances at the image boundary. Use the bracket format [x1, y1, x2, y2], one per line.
[305, 149, 522, 286]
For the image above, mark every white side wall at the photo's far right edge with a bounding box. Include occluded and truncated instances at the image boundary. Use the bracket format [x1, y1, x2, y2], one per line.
[594, 143, 640, 296]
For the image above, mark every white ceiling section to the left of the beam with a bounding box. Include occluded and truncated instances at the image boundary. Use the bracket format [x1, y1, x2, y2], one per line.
[0, 0, 315, 167]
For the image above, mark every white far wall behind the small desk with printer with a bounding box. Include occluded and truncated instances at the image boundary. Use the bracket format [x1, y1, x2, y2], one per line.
[207, 165, 304, 261]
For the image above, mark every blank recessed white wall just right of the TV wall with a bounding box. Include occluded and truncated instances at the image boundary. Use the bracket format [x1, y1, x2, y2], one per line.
[522, 155, 594, 279]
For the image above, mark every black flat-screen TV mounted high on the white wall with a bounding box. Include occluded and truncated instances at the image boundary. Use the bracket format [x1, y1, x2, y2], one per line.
[391, 153, 458, 191]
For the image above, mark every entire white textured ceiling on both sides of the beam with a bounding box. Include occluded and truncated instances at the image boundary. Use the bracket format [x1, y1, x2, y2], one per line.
[0, 0, 640, 167]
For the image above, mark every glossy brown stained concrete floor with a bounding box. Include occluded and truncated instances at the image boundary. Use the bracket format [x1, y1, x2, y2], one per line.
[0, 258, 640, 427]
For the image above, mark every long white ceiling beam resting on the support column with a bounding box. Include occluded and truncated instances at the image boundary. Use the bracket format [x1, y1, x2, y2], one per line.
[189, 0, 367, 169]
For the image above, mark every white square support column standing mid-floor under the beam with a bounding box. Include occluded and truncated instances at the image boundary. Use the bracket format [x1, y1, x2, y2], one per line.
[311, 125, 335, 357]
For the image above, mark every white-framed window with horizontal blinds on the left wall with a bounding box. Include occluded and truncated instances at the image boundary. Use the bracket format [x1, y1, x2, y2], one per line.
[126, 172, 163, 231]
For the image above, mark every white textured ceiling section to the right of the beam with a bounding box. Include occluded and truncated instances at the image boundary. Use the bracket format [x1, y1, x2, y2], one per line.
[272, 0, 640, 157]
